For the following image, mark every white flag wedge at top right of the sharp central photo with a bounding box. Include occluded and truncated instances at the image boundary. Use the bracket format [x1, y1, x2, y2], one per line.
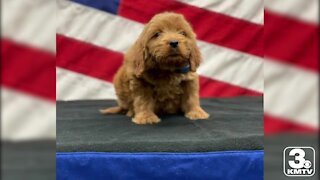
[178, 0, 264, 24]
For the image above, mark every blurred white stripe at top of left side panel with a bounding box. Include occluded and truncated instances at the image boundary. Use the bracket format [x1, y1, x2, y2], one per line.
[1, 0, 56, 52]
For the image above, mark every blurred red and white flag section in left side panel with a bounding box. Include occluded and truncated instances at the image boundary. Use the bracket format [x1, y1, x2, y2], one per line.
[1, 0, 56, 141]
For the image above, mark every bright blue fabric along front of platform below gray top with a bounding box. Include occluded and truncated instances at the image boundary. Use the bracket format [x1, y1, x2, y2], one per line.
[56, 150, 264, 180]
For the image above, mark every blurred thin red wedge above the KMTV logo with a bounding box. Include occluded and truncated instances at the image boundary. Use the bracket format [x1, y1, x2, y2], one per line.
[264, 114, 319, 135]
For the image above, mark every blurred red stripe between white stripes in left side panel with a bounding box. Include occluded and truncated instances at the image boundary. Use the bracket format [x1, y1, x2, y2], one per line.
[1, 39, 56, 101]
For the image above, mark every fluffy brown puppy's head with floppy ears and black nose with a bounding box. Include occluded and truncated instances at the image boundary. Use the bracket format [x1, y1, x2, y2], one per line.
[133, 12, 201, 76]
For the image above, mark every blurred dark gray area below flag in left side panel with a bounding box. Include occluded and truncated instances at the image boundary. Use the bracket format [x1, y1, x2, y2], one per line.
[1, 140, 56, 180]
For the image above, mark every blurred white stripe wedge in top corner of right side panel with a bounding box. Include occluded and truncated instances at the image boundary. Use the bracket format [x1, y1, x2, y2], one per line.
[265, 0, 319, 23]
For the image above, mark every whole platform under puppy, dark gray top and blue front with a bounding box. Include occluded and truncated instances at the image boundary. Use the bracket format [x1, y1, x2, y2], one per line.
[56, 97, 264, 180]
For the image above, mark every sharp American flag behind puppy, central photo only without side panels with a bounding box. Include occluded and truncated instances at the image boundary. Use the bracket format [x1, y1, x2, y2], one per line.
[57, 0, 263, 100]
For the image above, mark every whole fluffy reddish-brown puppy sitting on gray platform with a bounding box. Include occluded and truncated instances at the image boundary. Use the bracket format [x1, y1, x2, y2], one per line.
[100, 12, 209, 124]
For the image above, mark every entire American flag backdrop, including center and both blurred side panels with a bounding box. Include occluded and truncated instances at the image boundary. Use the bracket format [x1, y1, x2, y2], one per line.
[1, 0, 319, 179]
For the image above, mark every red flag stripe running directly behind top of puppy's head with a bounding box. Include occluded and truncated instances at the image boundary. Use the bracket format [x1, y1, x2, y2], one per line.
[118, 0, 264, 57]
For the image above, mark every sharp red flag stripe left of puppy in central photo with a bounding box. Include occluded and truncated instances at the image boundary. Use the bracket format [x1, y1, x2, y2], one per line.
[57, 35, 123, 82]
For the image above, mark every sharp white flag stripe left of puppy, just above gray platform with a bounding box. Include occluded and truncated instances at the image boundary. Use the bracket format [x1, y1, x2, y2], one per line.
[56, 68, 116, 100]
